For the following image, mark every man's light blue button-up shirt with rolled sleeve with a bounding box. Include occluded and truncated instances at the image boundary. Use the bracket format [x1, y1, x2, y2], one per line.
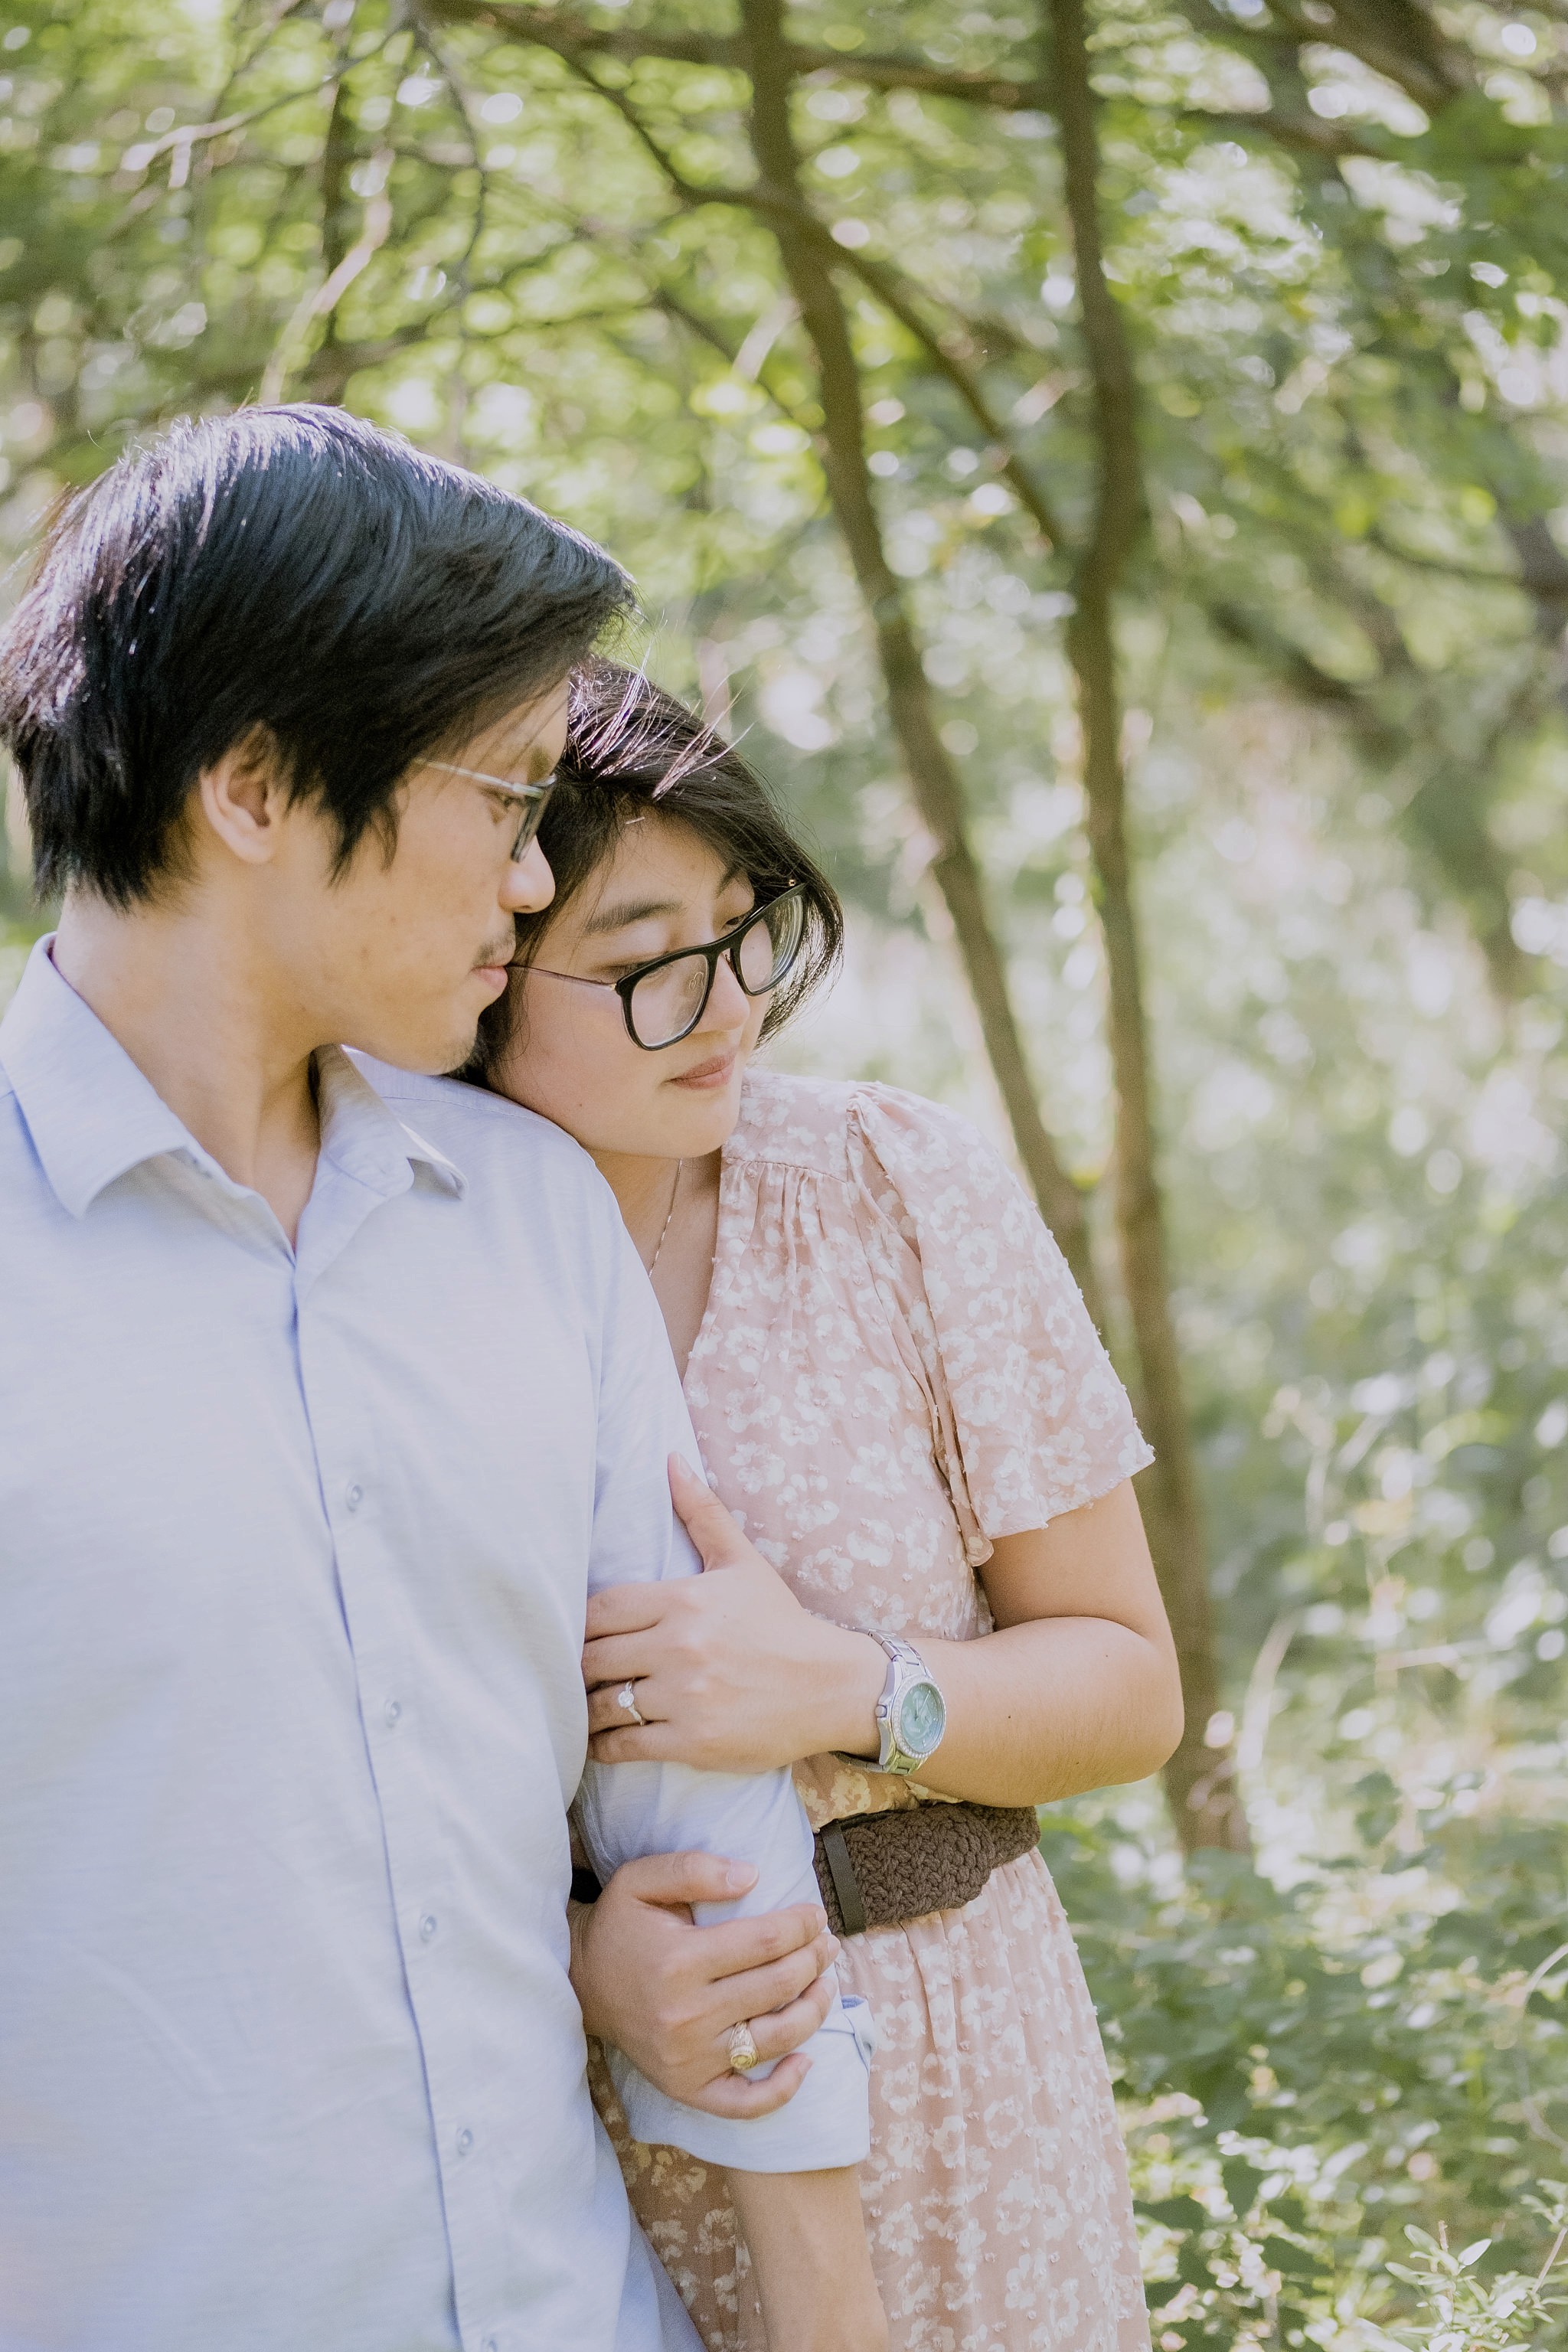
[0, 946, 867, 2352]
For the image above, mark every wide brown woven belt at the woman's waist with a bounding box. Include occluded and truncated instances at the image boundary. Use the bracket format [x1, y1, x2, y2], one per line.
[815, 1804, 1039, 1936]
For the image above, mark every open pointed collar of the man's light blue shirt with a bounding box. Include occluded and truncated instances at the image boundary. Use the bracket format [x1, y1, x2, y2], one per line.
[0, 936, 466, 1216]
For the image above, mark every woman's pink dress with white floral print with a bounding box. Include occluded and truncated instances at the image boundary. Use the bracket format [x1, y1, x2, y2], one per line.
[593, 1070, 1152, 2352]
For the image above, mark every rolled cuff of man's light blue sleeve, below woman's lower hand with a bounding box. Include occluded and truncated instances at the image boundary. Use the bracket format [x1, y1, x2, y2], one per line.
[604, 1997, 874, 2174]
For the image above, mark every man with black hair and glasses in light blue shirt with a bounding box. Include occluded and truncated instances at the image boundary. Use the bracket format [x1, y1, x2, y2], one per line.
[0, 410, 879, 2352]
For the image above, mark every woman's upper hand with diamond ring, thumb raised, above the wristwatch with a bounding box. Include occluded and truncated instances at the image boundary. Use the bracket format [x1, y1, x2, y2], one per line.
[583, 1456, 887, 1771]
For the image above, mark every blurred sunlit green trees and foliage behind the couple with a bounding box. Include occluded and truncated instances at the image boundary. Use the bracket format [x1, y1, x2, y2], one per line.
[0, 0, 1568, 2352]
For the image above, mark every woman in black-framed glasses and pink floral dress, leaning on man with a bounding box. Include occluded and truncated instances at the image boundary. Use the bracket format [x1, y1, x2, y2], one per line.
[475, 663, 1180, 2352]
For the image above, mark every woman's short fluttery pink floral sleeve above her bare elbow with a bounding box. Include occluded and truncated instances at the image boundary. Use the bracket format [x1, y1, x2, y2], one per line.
[848, 1086, 1155, 1566]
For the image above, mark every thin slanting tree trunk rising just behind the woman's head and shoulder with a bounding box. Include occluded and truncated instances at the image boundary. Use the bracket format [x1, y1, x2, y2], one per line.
[740, 0, 1105, 1327]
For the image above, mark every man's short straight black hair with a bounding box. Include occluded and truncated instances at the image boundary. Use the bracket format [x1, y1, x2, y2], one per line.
[0, 407, 630, 906]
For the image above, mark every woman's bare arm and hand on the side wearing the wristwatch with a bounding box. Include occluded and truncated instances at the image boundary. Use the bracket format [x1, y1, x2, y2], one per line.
[583, 1463, 1182, 1804]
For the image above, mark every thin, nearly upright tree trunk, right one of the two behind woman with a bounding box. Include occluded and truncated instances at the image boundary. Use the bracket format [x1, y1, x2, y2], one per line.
[1046, 0, 1248, 1851]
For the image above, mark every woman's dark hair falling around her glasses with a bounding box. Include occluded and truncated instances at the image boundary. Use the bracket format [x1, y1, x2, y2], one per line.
[461, 656, 844, 1086]
